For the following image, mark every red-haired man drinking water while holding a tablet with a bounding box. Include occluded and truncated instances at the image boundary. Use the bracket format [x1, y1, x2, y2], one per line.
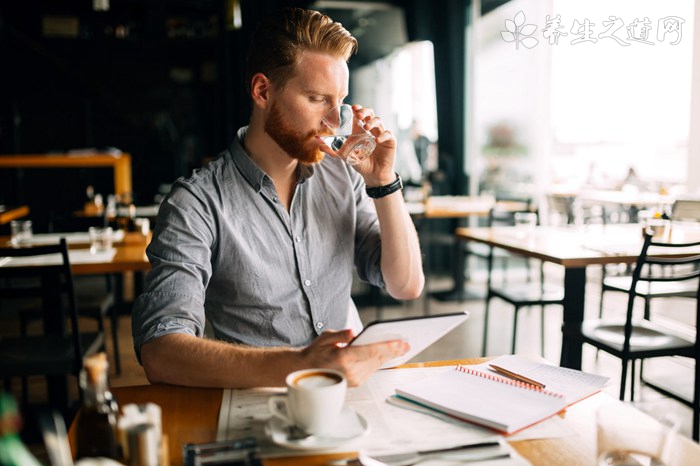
[133, 9, 424, 388]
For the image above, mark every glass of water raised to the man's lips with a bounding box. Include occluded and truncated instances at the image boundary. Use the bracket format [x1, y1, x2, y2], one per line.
[321, 104, 377, 165]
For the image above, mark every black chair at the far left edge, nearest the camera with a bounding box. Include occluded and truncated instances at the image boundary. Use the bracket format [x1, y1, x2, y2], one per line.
[0, 239, 104, 410]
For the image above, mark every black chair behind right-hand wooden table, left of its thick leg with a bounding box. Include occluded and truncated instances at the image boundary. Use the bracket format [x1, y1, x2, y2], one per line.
[481, 209, 564, 356]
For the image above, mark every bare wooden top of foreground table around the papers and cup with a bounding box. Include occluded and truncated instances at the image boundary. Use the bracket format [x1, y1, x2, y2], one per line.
[69, 359, 700, 466]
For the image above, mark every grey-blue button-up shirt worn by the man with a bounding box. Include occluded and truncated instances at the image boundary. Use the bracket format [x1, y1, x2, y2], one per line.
[132, 127, 384, 359]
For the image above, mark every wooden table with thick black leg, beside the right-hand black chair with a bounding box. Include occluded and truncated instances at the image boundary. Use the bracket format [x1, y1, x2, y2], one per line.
[456, 224, 700, 369]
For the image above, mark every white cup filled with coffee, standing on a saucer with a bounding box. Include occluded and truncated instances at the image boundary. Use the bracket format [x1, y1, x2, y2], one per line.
[268, 369, 348, 434]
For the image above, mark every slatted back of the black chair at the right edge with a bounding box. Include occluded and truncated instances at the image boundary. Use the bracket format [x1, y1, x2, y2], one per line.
[624, 233, 700, 351]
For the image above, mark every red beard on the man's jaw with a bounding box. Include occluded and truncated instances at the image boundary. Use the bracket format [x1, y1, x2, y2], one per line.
[265, 103, 325, 165]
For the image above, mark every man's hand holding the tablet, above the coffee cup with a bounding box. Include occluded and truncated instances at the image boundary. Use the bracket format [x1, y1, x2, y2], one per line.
[301, 330, 410, 387]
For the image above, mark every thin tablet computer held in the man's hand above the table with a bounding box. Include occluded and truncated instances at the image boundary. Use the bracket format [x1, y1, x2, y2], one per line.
[350, 311, 469, 369]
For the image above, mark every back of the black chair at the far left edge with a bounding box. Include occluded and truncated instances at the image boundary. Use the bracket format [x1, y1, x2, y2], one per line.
[0, 238, 83, 373]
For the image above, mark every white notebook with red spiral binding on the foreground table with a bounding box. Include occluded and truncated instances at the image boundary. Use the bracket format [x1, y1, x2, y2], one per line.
[396, 365, 567, 434]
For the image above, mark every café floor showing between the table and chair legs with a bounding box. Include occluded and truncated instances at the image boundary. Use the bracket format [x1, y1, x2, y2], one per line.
[0, 264, 695, 456]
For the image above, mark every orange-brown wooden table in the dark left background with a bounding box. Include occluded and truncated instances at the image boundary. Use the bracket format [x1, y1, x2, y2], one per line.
[0, 152, 133, 197]
